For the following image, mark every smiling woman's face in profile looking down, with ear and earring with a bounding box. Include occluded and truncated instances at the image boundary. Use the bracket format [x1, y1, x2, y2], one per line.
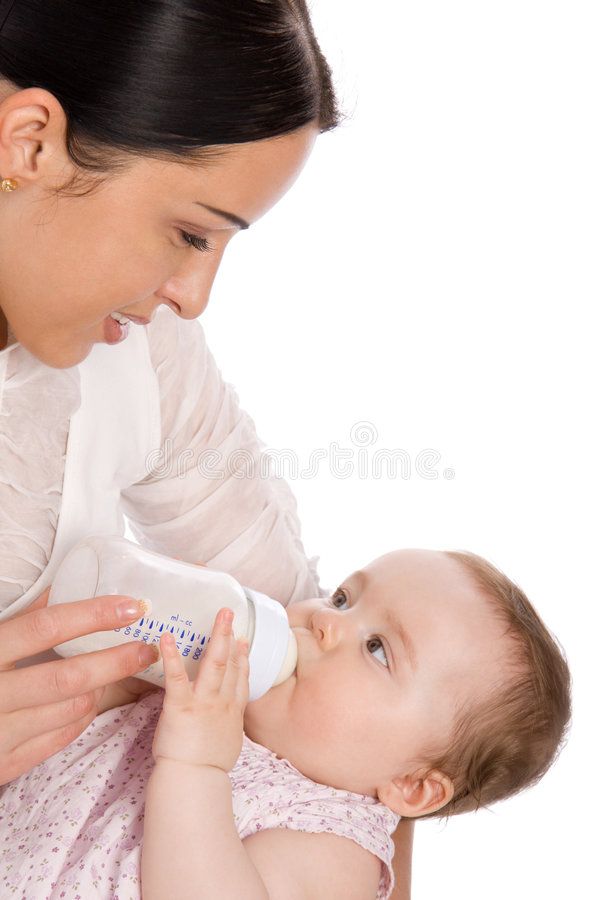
[0, 88, 318, 368]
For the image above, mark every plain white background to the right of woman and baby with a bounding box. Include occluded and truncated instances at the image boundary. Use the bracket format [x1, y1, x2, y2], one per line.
[201, 0, 600, 900]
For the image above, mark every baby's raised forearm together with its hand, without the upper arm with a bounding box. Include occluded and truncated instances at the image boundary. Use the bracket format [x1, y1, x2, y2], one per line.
[142, 607, 269, 900]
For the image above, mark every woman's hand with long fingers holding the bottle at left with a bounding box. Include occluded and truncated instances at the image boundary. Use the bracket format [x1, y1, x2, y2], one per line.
[0, 587, 157, 784]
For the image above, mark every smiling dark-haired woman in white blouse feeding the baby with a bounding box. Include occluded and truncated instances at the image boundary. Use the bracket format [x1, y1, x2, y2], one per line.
[0, 0, 412, 897]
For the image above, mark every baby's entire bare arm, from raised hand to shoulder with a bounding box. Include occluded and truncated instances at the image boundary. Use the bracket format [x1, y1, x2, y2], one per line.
[141, 608, 380, 900]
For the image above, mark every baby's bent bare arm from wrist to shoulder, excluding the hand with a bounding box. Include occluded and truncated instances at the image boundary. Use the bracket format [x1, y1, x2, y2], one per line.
[142, 759, 381, 900]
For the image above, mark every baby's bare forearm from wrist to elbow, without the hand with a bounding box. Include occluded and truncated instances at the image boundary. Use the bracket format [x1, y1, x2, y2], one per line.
[142, 759, 269, 900]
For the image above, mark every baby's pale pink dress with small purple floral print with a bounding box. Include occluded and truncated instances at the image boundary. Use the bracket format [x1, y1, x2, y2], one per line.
[0, 691, 399, 900]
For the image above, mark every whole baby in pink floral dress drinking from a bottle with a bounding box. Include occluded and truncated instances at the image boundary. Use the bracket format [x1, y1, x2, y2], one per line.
[0, 550, 570, 900]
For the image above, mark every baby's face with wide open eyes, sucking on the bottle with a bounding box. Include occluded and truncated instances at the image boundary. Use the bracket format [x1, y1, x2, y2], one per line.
[244, 550, 507, 802]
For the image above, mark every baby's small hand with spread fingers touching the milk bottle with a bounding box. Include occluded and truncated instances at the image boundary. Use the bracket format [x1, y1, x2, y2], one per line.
[152, 607, 249, 772]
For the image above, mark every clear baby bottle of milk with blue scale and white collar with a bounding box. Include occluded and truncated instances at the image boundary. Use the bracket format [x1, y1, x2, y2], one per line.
[48, 537, 298, 700]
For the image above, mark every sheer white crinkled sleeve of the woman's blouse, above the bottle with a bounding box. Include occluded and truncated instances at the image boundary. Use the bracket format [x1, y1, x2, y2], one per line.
[121, 307, 327, 606]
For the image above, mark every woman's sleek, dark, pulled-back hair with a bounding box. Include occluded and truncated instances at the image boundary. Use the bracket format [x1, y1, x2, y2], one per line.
[0, 0, 342, 194]
